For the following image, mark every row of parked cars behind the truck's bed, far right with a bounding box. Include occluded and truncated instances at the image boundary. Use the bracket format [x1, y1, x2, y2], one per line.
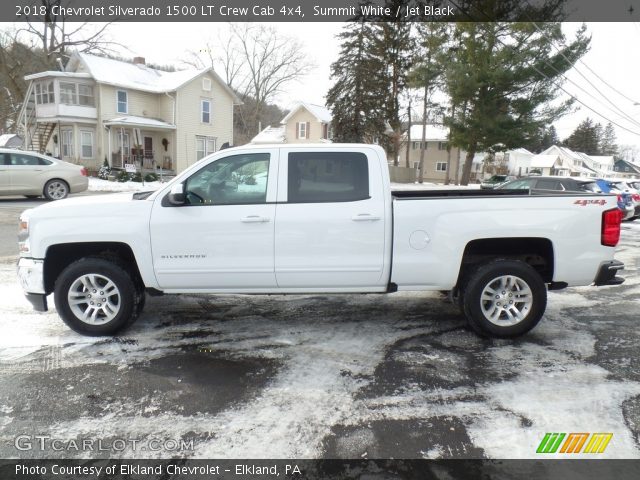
[481, 175, 640, 220]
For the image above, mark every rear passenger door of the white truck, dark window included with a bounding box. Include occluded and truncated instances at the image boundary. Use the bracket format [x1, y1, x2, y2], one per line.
[275, 147, 388, 289]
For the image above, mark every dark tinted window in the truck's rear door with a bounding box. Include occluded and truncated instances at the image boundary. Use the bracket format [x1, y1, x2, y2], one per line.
[288, 152, 369, 203]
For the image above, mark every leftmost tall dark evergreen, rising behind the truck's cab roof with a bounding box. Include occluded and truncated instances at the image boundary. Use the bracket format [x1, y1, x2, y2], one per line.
[327, 22, 386, 143]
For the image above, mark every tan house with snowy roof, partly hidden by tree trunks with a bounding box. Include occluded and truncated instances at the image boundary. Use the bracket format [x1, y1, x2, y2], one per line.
[399, 124, 464, 182]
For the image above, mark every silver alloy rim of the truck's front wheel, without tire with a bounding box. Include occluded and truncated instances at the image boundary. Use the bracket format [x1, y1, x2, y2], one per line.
[67, 273, 121, 325]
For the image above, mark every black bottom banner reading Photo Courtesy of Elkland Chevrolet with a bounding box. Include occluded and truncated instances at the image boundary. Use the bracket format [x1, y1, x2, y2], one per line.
[0, 459, 640, 480]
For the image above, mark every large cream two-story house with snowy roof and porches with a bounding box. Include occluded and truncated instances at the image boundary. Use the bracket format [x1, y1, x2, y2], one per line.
[19, 53, 242, 172]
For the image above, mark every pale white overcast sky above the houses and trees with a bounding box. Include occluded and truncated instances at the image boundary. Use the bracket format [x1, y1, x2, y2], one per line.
[38, 22, 640, 145]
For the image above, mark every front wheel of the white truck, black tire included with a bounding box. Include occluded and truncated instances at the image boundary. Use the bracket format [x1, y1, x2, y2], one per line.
[54, 257, 140, 336]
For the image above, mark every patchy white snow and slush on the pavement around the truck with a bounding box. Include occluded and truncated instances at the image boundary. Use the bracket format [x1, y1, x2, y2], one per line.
[0, 222, 640, 459]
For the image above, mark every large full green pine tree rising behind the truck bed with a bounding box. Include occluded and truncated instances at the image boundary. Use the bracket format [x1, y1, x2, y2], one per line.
[445, 17, 590, 185]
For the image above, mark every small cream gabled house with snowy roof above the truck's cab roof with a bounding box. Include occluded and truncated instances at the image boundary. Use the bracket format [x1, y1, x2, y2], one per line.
[250, 102, 333, 143]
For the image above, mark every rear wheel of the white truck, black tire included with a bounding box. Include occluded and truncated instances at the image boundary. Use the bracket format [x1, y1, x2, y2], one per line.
[462, 260, 547, 338]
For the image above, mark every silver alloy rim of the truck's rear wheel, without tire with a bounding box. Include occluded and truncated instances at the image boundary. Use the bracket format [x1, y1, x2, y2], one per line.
[480, 275, 533, 327]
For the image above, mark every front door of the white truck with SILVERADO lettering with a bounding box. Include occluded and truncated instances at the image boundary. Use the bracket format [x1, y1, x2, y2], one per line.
[150, 149, 278, 291]
